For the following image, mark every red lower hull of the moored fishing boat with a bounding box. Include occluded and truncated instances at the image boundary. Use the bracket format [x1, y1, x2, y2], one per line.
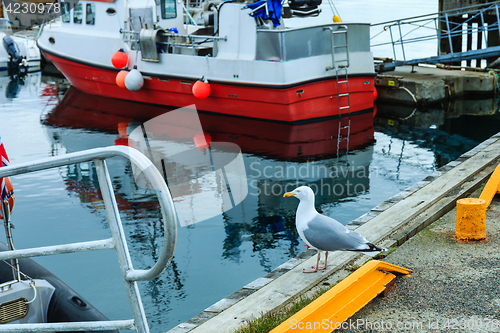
[44, 52, 374, 122]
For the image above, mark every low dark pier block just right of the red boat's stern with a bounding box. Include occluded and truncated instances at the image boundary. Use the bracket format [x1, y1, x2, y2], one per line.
[375, 66, 500, 106]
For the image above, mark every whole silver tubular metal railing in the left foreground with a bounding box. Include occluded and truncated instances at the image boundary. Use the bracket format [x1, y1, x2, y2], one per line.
[0, 146, 177, 333]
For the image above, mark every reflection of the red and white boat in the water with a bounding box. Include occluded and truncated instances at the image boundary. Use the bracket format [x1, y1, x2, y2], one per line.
[44, 88, 374, 222]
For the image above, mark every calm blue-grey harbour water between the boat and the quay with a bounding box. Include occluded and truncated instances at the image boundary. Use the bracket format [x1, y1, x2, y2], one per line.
[0, 73, 500, 332]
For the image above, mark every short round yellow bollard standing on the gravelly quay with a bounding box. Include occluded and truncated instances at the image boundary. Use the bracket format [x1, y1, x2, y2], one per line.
[455, 198, 486, 241]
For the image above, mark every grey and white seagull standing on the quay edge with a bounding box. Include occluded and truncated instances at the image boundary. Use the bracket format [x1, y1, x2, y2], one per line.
[283, 186, 387, 273]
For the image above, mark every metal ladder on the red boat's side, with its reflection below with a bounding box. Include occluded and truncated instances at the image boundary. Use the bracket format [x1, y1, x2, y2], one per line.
[324, 25, 351, 155]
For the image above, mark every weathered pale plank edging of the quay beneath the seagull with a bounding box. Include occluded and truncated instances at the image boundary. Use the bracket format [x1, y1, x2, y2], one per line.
[169, 133, 500, 333]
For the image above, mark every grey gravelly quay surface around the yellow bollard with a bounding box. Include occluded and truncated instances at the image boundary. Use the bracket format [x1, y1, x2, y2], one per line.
[339, 185, 500, 333]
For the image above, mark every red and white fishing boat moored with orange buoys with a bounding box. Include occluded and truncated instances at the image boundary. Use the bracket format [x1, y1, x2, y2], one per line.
[38, 0, 375, 123]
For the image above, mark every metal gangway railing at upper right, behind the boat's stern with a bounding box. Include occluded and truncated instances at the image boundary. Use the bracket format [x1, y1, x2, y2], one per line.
[371, 1, 500, 68]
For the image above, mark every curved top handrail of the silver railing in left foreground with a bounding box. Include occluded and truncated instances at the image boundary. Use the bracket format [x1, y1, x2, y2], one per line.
[0, 146, 177, 282]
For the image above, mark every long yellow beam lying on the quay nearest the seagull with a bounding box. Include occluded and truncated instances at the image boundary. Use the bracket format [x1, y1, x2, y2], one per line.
[271, 260, 411, 333]
